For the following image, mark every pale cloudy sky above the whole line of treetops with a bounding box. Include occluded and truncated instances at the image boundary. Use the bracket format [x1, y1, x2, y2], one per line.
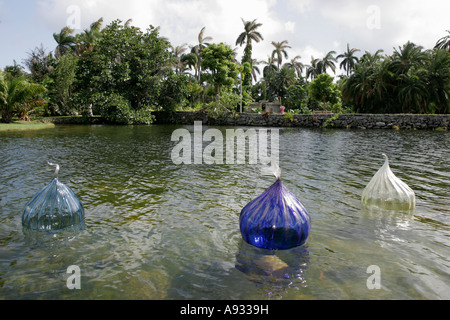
[0, 0, 450, 76]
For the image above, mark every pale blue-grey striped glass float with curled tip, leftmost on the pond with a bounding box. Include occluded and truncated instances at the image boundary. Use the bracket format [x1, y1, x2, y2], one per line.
[22, 163, 84, 232]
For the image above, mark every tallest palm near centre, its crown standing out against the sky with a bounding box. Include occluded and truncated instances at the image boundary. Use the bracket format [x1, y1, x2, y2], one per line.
[236, 18, 264, 86]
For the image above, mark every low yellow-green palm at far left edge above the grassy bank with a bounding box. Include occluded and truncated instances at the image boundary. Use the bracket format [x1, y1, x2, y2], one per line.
[0, 73, 46, 123]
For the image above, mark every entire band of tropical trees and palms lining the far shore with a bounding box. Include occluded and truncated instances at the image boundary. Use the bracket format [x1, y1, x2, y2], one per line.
[0, 18, 450, 124]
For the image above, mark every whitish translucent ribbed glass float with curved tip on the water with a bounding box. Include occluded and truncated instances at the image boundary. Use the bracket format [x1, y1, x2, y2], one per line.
[361, 154, 416, 210]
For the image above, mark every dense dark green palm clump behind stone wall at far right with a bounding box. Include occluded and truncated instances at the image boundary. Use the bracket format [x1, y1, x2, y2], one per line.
[342, 42, 450, 113]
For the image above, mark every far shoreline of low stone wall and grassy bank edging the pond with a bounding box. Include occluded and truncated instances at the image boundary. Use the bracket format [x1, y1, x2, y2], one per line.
[0, 111, 450, 132]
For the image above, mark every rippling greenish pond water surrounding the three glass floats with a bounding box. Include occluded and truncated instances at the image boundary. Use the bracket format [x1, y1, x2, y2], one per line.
[0, 125, 450, 300]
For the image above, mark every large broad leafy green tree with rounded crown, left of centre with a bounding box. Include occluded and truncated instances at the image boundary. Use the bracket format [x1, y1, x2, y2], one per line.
[76, 20, 173, 120]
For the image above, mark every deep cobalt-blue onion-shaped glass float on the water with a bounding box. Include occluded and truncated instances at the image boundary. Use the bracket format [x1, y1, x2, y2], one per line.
[239, 166, 311, 250]
